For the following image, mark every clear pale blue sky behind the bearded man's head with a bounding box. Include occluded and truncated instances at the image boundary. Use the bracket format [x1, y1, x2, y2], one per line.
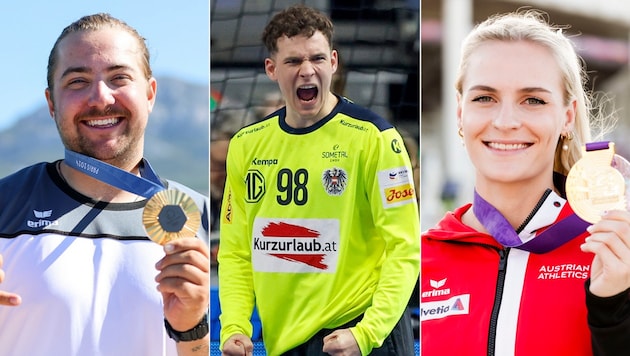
[0, 0, 209, 130]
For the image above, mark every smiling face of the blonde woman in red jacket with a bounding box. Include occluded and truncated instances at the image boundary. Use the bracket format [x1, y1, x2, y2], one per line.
[457, 41, 575, 189]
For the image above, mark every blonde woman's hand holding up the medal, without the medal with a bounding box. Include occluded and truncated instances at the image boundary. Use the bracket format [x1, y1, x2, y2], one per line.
[581, 210, 630, 297]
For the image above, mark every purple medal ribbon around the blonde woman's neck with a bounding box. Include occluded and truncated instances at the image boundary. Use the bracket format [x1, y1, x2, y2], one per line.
[473, 190, 590, 254]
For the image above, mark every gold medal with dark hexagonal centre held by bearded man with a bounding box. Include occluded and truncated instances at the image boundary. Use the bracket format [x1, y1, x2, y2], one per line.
[142, 189, 201, 245]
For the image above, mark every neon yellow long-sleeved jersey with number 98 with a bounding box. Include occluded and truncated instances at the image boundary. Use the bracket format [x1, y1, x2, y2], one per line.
[219, 98, 420, 355]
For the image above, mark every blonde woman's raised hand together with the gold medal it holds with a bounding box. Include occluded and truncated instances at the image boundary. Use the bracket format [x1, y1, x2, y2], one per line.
[566, 142, 630, 297]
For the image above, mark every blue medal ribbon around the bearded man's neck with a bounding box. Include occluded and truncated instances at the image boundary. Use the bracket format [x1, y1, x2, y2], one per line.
[64, 149, 165, 198]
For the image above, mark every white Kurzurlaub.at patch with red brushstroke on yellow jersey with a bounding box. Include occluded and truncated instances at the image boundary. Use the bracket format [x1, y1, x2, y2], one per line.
[252, 218, 339, 273]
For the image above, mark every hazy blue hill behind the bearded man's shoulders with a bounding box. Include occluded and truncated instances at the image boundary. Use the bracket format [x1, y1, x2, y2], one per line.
[0, 78, 209, 194]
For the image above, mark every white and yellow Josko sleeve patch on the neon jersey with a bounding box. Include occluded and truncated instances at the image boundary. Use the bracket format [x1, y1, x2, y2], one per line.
[378, 166, 416, 209]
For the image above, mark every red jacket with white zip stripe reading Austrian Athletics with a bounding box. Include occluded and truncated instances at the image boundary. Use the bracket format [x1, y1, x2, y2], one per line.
[420, 201, 600, 356]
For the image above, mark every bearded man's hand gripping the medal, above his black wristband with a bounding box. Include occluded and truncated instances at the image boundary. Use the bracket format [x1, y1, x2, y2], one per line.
[155, 238, 210, 331]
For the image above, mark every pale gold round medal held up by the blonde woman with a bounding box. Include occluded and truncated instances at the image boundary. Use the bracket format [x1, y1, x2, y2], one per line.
[566, 141, 630, 224]
